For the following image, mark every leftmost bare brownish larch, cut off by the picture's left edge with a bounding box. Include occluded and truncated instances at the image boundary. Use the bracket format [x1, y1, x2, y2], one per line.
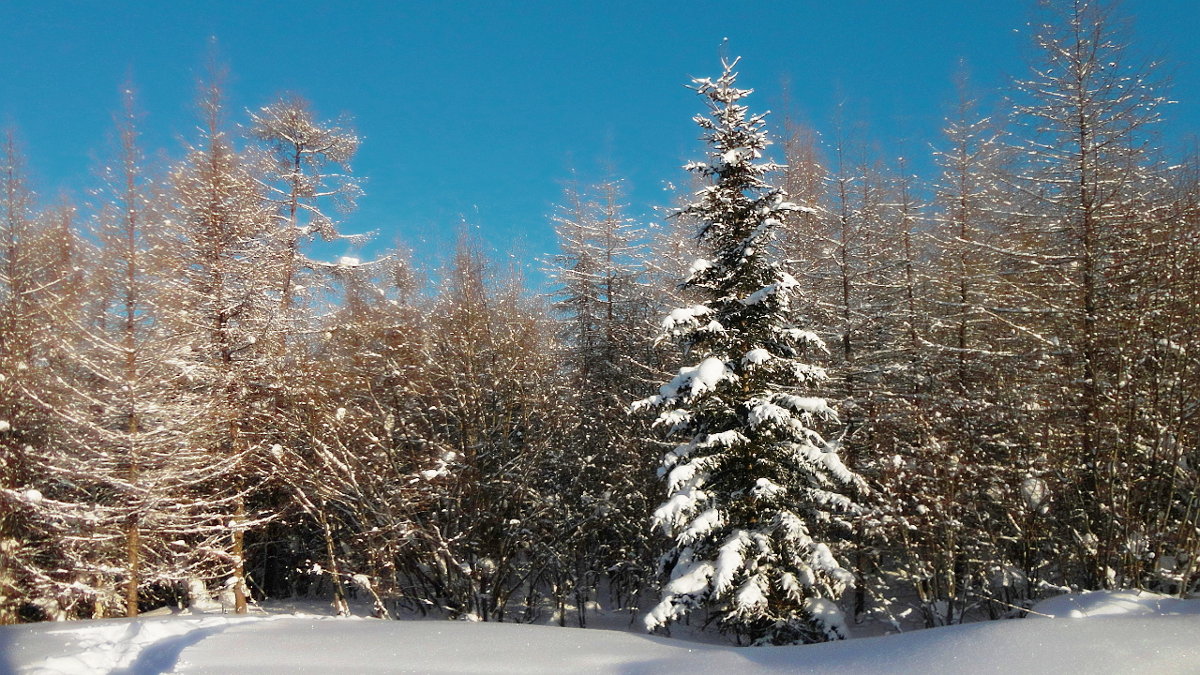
[0, 131, 100, 623]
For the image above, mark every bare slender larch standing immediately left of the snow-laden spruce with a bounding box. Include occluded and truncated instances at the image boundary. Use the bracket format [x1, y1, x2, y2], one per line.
[551, 180, 655, 625]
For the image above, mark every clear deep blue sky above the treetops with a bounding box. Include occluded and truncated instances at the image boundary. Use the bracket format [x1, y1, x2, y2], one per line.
[0, 0, 1200, 284]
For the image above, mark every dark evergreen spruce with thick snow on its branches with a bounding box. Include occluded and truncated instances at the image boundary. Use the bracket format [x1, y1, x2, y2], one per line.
[634, 59, 865, 645]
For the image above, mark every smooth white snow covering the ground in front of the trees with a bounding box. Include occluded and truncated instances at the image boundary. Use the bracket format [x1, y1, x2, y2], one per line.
[0, 592, 1200, 675]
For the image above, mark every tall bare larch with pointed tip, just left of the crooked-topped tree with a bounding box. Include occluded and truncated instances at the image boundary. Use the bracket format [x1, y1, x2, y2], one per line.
[163, 72, 282, 614]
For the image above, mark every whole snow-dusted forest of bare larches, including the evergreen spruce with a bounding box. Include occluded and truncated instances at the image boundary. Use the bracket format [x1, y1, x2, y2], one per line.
[0, 1, 1200, 644]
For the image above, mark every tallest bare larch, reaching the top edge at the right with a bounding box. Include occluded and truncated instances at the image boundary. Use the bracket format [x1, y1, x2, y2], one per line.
[1013, 0, 1165, 587]
